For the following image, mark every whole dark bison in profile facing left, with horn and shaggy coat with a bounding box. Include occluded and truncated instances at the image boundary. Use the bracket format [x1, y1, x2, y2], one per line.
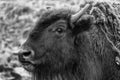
[19, 2, 120, 80]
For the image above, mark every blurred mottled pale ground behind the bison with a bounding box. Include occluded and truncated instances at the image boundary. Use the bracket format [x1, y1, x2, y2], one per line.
[0, 0, 120, 80]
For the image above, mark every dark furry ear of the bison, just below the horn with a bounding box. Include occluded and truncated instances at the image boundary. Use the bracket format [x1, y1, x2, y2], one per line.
[73, 14, 94, 34]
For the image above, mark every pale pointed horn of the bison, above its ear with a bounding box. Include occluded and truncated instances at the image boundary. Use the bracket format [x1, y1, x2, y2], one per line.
[71, 4, 91, 23]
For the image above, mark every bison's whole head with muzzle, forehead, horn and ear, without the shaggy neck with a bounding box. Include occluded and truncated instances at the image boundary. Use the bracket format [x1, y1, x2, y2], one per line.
[19, 5, 95, 80]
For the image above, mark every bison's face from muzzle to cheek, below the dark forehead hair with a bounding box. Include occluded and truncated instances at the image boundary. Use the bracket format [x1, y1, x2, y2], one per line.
[20, 20, 78, 71]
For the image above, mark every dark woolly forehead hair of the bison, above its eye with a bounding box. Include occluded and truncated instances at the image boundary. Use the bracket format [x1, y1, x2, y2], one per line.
[31, 9, 73, 31]
